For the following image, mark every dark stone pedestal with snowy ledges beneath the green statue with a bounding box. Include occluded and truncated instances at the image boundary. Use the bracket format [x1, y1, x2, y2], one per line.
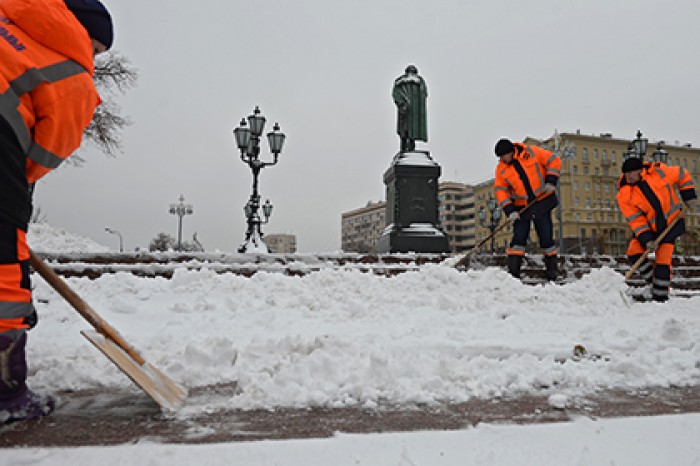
[377, 150, 450, 253]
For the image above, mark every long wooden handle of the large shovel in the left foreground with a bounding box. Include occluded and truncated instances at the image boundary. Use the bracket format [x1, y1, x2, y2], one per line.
[29, 249, 146, 365]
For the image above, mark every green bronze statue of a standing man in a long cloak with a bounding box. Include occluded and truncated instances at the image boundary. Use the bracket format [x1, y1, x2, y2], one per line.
[391, 65, 428, 152]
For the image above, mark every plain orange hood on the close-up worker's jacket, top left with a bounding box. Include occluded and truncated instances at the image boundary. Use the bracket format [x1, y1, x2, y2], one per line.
[0, 0, 95, 76]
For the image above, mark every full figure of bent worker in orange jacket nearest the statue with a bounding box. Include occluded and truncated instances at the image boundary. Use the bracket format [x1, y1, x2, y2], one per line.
[494, 139, 561, 280]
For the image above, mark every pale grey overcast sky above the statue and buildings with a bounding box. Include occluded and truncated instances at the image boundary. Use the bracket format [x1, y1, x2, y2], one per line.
[35, 0, 700, 252]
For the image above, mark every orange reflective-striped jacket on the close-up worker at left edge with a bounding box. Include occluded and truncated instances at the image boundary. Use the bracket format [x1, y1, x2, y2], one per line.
[0, 0, 100, 183]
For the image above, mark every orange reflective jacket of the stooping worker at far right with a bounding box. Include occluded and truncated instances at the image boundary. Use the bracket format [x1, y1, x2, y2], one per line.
[617, 162, 697, 245]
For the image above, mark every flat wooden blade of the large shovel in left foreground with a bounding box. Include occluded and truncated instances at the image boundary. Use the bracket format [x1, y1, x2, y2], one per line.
[80, 330, 187, 413]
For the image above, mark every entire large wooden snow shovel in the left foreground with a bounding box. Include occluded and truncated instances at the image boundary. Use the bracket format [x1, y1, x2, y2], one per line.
[29, 250, 187, 412]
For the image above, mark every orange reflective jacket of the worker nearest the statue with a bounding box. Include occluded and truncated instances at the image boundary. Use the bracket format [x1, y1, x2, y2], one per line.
[494, 142, 561, 215]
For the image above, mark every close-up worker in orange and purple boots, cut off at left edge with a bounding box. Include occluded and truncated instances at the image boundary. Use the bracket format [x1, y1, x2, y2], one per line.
[0, 0, 113, 424]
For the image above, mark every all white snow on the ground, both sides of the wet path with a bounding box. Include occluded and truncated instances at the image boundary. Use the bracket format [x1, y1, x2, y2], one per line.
[0, 226, 700, 465]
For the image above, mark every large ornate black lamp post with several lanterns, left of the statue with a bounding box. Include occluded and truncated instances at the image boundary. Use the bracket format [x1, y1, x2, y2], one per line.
[233, 106, 286, 253]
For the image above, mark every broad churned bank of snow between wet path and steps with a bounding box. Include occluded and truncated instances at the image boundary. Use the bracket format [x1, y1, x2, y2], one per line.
[28, 265, 700, 416]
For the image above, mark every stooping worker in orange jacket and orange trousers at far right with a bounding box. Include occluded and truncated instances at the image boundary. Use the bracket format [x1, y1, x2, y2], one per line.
[617, 157, 697, 302]
